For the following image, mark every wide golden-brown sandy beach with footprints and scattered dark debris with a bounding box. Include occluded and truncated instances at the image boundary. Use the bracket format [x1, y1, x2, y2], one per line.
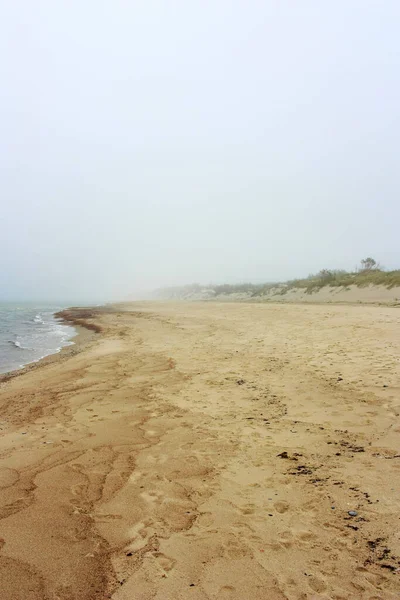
[0, 303, 400, 600]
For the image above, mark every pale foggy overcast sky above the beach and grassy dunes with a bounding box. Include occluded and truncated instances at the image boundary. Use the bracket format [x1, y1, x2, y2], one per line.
[0, 0, 400, 301]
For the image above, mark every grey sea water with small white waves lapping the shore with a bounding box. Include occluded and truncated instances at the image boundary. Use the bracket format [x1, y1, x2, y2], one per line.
[0, 303, 76, 373]
